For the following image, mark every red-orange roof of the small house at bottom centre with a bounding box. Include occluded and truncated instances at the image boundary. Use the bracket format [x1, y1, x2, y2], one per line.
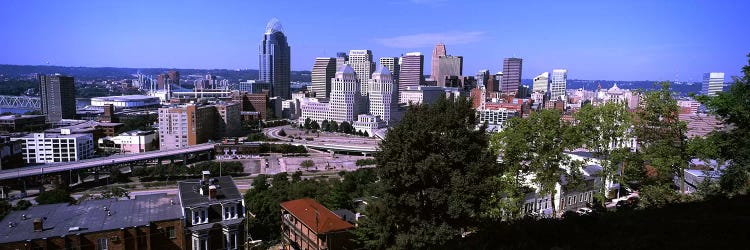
[281, 198, 354, 234]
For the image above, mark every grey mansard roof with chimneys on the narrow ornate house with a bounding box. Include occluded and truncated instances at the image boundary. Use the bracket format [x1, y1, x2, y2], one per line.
[178, 176, 242, 207]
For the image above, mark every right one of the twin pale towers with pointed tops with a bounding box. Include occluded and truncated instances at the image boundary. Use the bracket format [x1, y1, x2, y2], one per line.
[369, 66, 398, 124]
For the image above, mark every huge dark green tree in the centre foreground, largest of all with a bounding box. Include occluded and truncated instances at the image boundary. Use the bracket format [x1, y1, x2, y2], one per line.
[357, 97, 499, 249]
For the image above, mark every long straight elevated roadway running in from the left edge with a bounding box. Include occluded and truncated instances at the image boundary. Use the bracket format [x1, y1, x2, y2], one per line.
[0, 143, 216, 180]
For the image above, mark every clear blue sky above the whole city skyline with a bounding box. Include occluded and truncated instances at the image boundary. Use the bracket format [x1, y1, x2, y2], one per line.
[0, 0, 750, 81]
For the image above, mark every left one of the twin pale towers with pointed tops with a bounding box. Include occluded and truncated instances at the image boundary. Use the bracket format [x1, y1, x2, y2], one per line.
[328, 64, 362, 123]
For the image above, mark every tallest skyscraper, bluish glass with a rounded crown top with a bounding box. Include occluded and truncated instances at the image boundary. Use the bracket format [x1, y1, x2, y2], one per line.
[259, 18, 292, 99]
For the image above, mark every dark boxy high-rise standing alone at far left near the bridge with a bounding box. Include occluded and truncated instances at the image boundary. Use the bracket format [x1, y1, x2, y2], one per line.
[38, 74, 76, 123]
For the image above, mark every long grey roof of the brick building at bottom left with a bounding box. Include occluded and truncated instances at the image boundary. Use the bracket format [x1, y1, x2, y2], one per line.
[0, 194, 182, 243]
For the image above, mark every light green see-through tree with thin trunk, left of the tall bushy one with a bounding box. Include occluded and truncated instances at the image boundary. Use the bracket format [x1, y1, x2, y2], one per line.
[574, 102, 632, 202]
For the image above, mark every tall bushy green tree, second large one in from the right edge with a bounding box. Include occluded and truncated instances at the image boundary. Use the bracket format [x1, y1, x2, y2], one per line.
[634, 82, 690, 191]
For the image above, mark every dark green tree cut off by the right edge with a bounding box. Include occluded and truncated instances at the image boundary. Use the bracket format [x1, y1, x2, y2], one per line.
[698, 54, 750, 195]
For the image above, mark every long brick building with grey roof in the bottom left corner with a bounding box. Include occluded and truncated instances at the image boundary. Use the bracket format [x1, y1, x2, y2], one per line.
[0, 194, 185, 250]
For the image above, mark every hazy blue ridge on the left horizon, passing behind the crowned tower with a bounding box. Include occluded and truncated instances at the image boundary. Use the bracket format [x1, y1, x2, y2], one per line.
[0, 64, 310, 82]
